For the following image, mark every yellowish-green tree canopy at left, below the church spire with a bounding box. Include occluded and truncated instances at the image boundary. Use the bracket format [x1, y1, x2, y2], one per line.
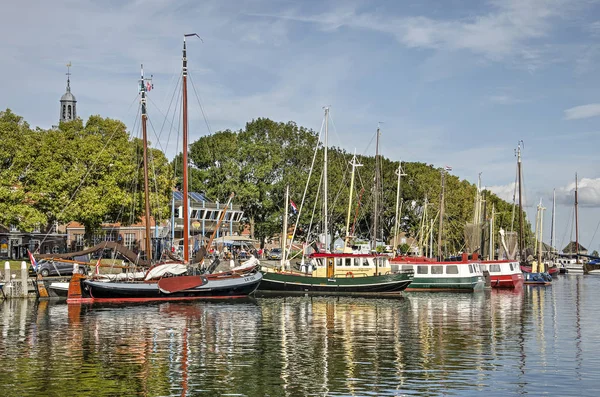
[0, 110, 174, 235]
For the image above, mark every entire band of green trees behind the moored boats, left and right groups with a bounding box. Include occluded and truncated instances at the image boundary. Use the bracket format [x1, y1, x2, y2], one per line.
[0, 110, 531, 253]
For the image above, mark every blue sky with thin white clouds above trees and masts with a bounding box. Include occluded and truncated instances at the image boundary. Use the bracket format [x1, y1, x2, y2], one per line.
[0, 0, 600, 250]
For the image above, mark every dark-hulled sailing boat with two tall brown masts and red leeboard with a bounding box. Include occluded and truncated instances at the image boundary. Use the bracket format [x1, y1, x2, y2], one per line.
[67, 34, 262, 303]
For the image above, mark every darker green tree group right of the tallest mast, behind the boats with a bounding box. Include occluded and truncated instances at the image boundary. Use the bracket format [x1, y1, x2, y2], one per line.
[176, 118, 528, 253]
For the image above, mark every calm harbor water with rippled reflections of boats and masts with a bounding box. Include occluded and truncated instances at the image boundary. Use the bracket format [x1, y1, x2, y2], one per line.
[0, 276, 600, 396]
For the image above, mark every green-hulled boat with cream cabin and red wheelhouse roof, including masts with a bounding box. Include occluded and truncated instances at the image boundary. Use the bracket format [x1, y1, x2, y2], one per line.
[258, 107, 413, 296]
